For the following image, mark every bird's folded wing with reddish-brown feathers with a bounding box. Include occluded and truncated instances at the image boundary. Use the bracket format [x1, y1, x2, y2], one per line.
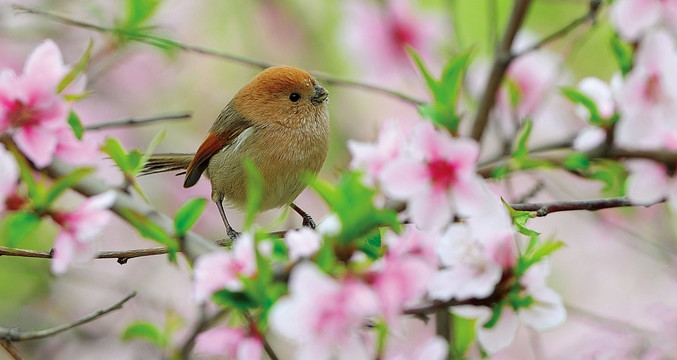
[183, 110, 252, 188]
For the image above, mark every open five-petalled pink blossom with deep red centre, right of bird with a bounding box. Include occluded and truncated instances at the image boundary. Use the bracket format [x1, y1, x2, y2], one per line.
[379, 122, 482, 229]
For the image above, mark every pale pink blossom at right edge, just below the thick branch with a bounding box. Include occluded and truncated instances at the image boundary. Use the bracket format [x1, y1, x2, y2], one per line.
[626, 160, 677, 211]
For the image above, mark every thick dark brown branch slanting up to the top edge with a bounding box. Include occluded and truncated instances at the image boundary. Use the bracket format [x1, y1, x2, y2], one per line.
[470, 0, 531, 141]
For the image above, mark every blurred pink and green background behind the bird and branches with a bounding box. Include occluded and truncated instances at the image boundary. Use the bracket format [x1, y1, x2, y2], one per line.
[0, 0, 677, 359]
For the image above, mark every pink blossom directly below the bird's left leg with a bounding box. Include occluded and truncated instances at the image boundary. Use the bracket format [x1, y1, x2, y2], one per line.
[194, 232, 256, 302]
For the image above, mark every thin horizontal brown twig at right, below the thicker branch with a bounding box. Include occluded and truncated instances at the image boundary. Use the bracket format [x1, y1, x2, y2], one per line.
[510, 197, 665, 217]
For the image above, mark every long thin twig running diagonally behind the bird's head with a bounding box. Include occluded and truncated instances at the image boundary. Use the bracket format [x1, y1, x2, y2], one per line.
[12, 4, 425, 106]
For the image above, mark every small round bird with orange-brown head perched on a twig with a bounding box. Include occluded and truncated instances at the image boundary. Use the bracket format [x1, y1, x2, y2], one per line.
[141, 66, 329, 239]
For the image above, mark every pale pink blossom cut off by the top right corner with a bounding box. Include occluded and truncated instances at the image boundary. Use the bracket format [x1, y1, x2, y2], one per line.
[610, 0, 677, 41]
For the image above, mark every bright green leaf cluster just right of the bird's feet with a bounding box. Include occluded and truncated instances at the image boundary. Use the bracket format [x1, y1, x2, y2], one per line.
[311, 172, 401, 245]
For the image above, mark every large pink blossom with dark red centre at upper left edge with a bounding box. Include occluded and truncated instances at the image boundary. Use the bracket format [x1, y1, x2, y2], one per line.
[0, 40, 86, 167]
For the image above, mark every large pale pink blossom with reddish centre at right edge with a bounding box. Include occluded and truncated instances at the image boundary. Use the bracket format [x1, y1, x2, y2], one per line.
[614, 31, 677, 150]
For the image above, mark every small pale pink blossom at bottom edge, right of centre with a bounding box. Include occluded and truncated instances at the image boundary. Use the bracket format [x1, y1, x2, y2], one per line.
[383, 317, 448, 360]
